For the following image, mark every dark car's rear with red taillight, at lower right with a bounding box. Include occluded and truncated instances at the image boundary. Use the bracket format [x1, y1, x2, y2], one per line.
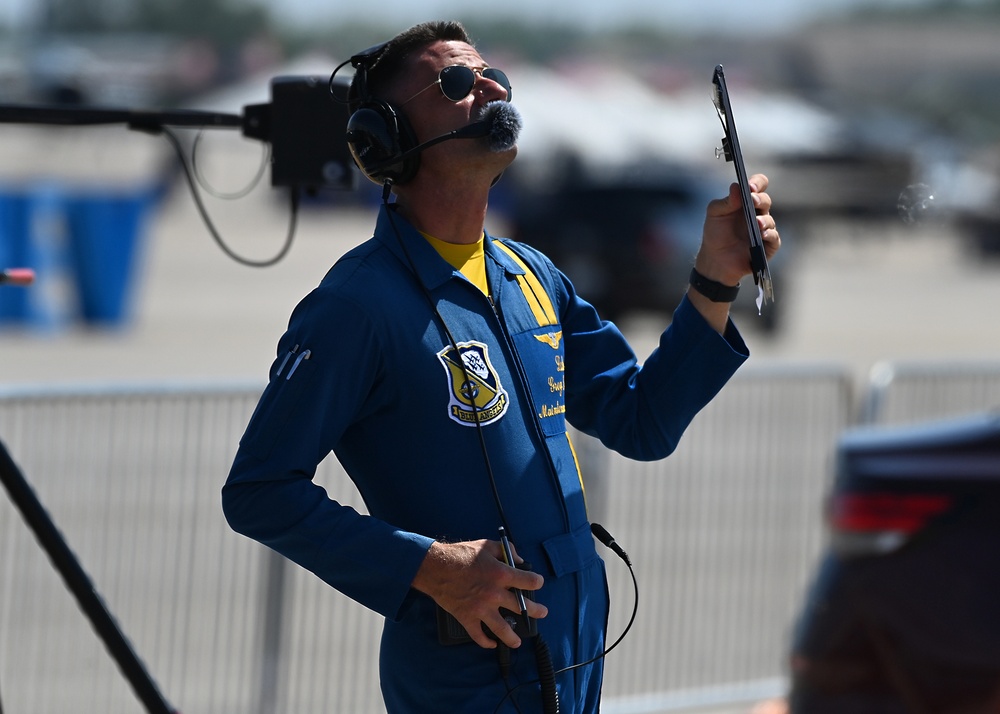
[789, 412, 1000, 714]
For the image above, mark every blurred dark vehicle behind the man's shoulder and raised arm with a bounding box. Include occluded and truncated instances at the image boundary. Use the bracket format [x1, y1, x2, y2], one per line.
[509, 163, 783, 330]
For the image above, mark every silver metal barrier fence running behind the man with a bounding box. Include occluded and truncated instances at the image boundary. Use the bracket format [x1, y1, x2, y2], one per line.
[0, 368, 853, 714]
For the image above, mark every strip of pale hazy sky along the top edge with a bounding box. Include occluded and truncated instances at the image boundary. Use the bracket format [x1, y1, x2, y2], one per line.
[0, 0, 928, 35]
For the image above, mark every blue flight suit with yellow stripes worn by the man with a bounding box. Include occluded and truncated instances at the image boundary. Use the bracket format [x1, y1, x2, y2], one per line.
[223, 206, 747, 714]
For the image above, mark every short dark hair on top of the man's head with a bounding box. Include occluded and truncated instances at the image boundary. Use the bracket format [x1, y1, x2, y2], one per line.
[347, 20, 474, 111]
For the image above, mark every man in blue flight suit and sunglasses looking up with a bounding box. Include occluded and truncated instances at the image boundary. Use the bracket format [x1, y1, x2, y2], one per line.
[223, 23, 780, 714]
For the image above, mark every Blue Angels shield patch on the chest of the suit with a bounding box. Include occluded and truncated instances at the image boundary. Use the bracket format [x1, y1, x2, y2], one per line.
[438, 342, 510, 426]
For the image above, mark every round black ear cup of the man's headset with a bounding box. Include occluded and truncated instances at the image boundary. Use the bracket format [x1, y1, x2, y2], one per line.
[347, 101, 420, 185]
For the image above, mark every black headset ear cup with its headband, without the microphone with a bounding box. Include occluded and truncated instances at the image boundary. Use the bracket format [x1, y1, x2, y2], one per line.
[344, 42, 420, 185]
